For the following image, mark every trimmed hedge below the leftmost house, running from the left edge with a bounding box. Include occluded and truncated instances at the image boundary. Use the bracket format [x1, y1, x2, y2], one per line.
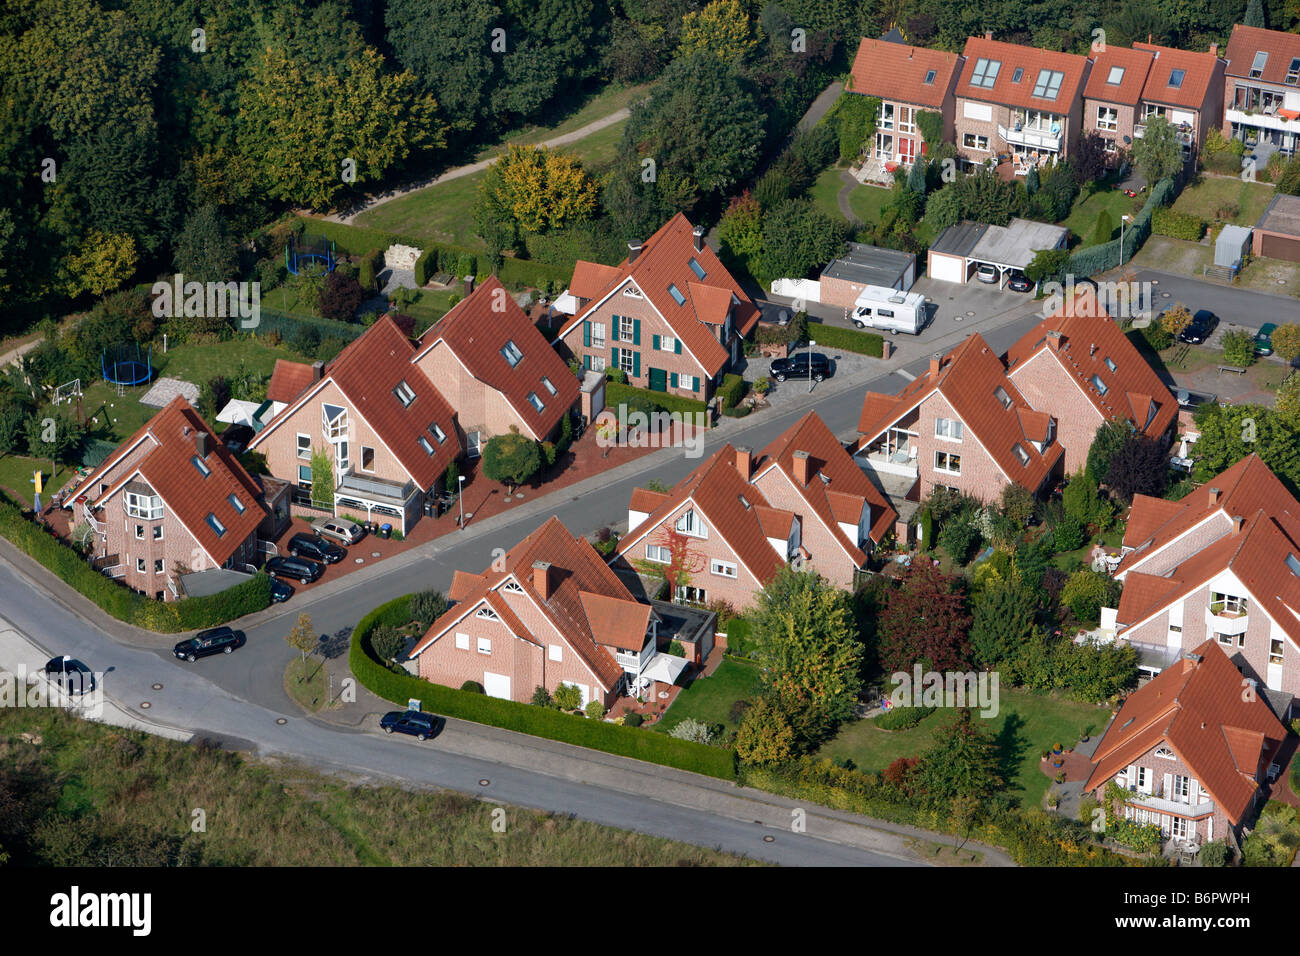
[0, 493, 270, 632]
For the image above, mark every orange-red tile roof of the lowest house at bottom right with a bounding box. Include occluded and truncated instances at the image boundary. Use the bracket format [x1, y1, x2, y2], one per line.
[1086, 640, 1286, 825]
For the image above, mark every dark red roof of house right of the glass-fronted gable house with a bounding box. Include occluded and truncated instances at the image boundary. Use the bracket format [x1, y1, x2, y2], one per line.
[416, 276, 579, 441]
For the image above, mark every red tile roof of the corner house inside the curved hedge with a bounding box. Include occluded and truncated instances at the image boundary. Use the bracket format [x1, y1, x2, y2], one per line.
[411, 518, 651, 689]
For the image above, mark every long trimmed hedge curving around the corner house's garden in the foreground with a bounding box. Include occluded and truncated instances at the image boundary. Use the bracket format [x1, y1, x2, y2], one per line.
[348, 594, 736, 780]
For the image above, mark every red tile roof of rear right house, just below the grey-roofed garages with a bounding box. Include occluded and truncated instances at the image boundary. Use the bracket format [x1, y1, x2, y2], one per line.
[1006, 286, 1178, 437]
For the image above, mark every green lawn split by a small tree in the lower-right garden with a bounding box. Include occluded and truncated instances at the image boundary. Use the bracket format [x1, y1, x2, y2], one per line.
[818, 688, 1108, 806]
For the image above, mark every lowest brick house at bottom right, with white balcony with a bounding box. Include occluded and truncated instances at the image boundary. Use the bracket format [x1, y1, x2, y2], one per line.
[1084, 640, 1287, 848]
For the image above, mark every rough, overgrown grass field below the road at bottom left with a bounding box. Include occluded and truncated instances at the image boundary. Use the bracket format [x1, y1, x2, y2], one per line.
[0, 708, 746, 868]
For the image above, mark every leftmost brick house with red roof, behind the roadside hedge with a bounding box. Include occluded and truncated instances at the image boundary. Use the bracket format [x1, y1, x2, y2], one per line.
[72, 397, 269, 601]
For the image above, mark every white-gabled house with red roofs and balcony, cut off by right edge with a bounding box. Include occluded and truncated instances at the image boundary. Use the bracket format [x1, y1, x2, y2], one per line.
[1114, 454, 1300, 718]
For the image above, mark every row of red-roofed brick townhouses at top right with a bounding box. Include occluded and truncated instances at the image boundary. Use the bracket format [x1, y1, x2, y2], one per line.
[849, 25, 1300, 178]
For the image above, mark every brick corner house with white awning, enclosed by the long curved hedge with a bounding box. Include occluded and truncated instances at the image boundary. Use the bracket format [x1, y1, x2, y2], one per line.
[406, 518, 686, 709]
